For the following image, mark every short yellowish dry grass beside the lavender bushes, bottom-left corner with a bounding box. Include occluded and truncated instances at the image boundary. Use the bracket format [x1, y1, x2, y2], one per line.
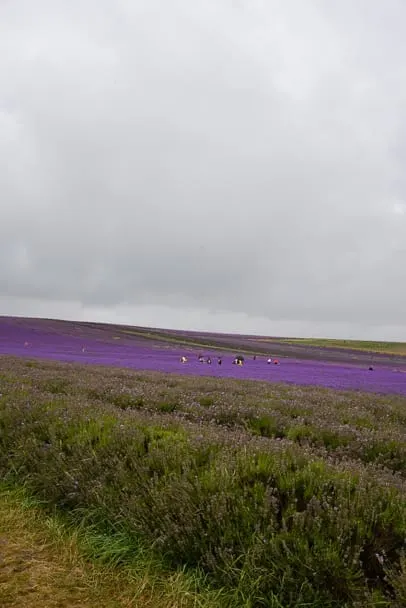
[0, 484, 222, 608]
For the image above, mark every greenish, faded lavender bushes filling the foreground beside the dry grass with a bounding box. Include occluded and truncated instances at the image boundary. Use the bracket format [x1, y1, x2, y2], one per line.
[0, 358, 406, 608]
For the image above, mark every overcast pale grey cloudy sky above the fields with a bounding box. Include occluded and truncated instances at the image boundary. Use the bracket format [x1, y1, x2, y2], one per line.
[0, 0, 406, 339]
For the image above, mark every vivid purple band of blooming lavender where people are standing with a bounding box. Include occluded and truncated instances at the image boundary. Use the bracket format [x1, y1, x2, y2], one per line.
[0, 318, 406, 395]
